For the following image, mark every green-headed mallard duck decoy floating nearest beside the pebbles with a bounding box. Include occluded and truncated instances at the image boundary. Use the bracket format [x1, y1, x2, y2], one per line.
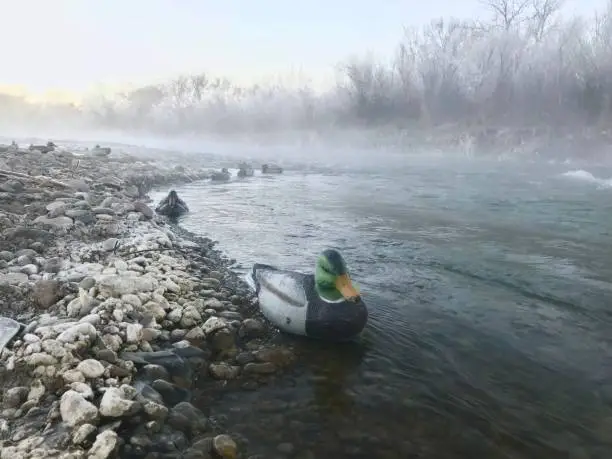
[250, 249, 368, 341]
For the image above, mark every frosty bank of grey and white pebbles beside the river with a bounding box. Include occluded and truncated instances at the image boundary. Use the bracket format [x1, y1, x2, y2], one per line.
[0, 147, 293, 459]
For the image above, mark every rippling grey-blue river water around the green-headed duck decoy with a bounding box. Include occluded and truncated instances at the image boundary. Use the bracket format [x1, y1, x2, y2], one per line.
[154, 157, 612, 459]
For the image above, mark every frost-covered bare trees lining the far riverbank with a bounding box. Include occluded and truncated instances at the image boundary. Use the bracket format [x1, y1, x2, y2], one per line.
[3, 0, 612, 142]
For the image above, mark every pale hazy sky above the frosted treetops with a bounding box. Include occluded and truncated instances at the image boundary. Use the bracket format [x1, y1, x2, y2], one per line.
[0, 0, 605, 100]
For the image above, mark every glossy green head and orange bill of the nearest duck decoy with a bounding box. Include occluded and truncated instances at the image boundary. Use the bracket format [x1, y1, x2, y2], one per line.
[315, 249, 360, 302]
